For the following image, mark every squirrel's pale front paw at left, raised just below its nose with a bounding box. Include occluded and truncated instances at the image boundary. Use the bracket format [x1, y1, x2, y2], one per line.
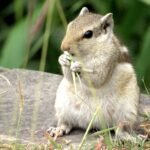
[58, 53, 71, 67]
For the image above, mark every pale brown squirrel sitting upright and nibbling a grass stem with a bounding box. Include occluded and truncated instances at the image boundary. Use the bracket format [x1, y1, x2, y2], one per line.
[47, 7, 140, 139]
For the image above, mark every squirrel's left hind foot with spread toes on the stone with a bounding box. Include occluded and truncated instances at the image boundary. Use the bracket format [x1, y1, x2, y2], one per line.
[47, 125, 71, 137]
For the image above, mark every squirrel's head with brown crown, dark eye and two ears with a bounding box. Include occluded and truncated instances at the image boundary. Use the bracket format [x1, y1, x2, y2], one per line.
[61, 7, 114, 55]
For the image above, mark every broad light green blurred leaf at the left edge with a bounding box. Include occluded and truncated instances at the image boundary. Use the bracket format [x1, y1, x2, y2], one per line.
[0, 20, 27, 68]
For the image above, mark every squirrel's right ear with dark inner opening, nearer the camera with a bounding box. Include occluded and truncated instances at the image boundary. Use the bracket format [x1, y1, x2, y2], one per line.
[101, 13, 114, 33]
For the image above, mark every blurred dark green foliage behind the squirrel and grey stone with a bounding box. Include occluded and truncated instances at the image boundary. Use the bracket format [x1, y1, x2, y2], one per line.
[0, 0, 150, 90]
